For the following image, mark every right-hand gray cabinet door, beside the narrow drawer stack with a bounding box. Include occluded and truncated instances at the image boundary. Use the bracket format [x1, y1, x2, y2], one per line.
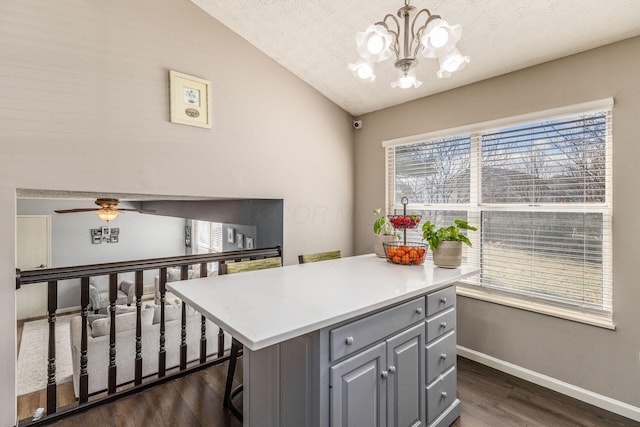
[387, 323, 426, 427]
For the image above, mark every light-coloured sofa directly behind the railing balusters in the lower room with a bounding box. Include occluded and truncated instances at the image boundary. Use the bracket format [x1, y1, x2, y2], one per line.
[70, 299, 231, 397]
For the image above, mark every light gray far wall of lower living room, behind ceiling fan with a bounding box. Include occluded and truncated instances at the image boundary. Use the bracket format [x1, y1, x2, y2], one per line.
[17, 199, 185, 308]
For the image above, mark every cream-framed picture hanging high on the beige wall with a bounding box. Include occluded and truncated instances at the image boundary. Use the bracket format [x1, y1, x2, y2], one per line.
[169, 71, 211, 129]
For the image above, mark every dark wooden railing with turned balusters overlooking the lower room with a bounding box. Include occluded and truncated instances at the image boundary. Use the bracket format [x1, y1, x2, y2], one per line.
[16, 247, 282, 425]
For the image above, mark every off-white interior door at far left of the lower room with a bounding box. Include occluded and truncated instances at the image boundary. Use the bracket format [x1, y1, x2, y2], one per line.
[16, 215, 51, 320]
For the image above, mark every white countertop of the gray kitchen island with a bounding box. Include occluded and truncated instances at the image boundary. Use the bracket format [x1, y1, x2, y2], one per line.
[167, 254, 479, 351]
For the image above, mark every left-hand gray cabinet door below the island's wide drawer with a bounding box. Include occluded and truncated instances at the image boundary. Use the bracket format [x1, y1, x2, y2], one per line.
[331, 343, 387, 427]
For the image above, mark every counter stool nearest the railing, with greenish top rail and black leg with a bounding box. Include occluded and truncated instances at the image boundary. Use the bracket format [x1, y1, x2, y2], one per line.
[218, 257, 282, 421]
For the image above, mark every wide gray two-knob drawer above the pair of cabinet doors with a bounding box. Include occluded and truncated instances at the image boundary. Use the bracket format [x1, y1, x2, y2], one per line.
[329, 297, 424, 362]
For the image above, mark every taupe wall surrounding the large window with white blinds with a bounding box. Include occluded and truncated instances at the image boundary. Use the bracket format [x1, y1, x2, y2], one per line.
[354, 38, 640, 407]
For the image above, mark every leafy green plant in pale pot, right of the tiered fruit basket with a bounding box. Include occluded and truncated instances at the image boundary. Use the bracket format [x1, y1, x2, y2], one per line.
[422, 219, 477, 268]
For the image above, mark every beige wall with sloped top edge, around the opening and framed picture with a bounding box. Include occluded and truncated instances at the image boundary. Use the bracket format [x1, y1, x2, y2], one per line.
[0, 0, 354, 427]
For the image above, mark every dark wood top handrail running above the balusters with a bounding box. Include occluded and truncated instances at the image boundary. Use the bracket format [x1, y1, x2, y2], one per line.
[16, 246, 281, 289]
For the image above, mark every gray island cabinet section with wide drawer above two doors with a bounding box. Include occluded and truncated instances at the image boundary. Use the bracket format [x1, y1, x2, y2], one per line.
[330, 298, 426, 427]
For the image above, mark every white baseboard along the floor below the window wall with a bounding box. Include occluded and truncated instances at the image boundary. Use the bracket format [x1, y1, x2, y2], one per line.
[457, 346, 640, 421]
